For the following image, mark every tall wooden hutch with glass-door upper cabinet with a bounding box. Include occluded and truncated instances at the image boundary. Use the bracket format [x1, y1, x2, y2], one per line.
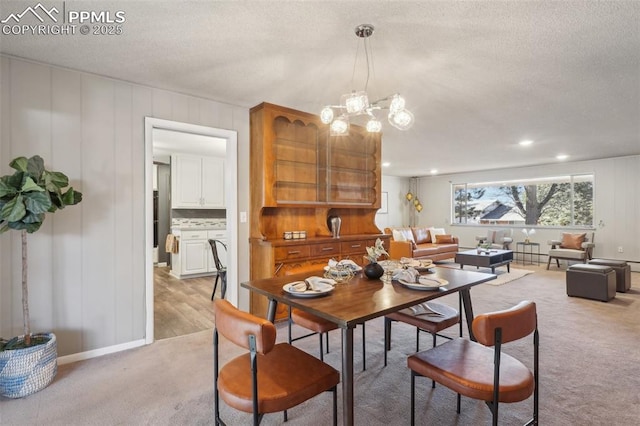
[250, 103, 389, 319]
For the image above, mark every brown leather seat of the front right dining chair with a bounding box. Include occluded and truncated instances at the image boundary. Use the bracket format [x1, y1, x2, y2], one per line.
[407, 338, 535, 402]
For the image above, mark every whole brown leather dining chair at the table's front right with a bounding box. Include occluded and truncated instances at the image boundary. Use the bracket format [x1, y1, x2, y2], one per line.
[407, 301, 539, 425]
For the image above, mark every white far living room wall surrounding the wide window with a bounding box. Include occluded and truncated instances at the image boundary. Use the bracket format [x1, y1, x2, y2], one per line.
[418, 156, 640, 269]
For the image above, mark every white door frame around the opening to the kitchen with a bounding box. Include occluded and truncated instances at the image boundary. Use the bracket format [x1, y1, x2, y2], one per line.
[145, 117, 238, 344]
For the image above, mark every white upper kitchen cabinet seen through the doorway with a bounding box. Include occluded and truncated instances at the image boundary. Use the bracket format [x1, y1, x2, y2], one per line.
[171, 154, 224, 209]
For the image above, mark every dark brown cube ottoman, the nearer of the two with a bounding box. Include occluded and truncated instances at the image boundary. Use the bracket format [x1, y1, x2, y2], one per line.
[567, 263, 616, 302]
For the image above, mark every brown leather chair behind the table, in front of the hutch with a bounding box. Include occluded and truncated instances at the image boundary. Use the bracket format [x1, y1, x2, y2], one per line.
[284, 265, 367, 371]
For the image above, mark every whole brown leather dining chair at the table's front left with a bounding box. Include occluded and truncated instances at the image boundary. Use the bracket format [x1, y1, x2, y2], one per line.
[213, 299, 340, 425]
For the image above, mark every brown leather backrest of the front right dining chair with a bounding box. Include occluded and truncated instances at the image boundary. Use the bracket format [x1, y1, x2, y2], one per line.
[472, 300, 538, 346]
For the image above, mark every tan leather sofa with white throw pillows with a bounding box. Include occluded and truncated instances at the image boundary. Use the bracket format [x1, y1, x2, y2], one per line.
[384, 226, 458, 261]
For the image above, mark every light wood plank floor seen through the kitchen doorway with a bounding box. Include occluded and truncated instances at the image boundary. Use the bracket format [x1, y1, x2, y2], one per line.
[153, 267, 221, 340]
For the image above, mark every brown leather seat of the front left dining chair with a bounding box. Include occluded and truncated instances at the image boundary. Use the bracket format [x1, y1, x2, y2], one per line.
[218, 343, 340, 413]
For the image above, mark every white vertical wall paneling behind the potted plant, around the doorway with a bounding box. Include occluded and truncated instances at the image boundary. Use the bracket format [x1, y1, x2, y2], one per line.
[0, 56, 249, 359]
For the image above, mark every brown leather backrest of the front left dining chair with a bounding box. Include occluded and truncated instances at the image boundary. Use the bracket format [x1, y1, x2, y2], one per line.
[214, 299, 276, 354]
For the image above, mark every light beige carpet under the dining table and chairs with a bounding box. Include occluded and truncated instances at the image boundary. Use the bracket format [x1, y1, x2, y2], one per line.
[0, 265, 640, 426]
